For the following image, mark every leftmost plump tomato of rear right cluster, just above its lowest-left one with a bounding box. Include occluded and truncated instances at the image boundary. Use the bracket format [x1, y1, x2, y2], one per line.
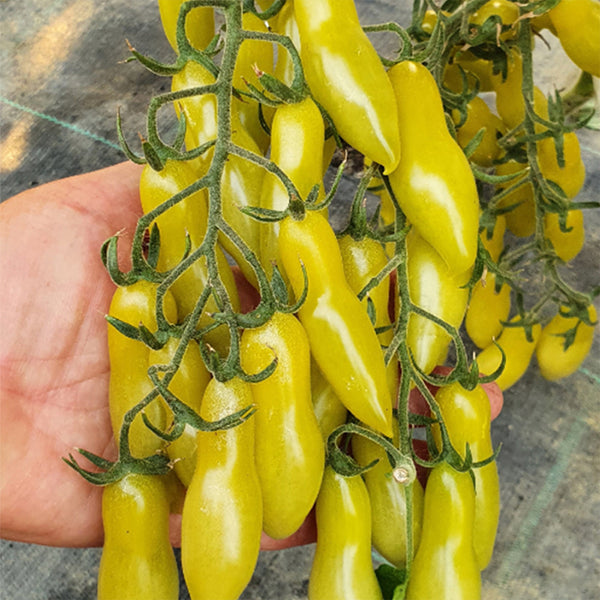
[465, 273, 510, 348]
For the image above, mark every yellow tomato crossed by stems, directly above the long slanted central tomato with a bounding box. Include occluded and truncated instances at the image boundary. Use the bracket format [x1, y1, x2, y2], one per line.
[260, 96, 325, 275]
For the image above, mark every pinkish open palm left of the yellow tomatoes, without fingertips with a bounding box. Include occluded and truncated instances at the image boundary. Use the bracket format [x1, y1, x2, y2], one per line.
[0, 164, 141, 546]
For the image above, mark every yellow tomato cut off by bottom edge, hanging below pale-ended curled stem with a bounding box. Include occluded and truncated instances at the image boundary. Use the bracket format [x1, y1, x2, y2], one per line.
[308, 466, 382, 600]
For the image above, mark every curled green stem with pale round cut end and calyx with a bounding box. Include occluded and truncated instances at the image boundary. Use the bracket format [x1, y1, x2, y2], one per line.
[327, 423, 417, 485]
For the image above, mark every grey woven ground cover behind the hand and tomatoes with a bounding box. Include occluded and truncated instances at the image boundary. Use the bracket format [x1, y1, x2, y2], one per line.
[0, 0, 600, 600]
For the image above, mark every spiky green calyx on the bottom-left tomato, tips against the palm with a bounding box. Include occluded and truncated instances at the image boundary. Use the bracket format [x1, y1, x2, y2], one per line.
[63, 448, 171, 485]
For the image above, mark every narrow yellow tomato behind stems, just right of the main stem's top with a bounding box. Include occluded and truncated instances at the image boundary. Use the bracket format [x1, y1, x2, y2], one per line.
[231, 12, 273, 153]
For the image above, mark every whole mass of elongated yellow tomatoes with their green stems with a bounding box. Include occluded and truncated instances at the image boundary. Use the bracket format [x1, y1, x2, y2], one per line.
[68, 0, 600, 600]
